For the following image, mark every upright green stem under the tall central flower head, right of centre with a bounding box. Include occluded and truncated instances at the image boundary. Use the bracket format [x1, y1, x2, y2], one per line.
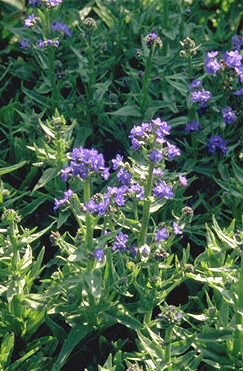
[139, 161, 154, 246]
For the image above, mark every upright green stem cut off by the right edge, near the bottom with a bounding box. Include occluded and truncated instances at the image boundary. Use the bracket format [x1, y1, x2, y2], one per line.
[233, 254, 243, 357]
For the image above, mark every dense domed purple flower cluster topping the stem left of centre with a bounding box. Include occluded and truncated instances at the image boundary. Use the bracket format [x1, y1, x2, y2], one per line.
[61, 147, 110, 182]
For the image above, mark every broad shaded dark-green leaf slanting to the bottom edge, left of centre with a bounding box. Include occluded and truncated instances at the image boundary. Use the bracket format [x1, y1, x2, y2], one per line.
[51, 324, 93, 371]
